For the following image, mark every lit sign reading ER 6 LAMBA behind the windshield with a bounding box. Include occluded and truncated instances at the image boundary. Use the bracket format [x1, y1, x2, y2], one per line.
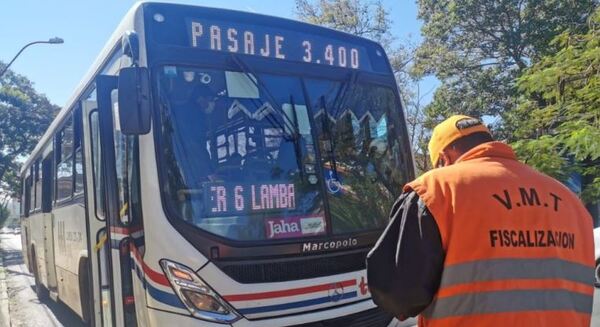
[204, 183, 296, 216]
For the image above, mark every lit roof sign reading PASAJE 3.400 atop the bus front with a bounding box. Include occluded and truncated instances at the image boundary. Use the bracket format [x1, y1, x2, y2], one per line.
[188, 19, 371, 70]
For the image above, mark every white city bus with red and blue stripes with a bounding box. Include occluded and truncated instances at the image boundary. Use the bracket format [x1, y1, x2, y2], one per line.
[21, 2, 414, 327]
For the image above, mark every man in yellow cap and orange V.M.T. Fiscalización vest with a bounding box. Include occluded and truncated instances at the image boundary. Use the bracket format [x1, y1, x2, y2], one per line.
[367, 116, 594, 327]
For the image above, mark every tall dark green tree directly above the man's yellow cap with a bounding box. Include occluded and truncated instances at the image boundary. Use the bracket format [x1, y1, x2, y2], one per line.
[413, 0, 597, 138]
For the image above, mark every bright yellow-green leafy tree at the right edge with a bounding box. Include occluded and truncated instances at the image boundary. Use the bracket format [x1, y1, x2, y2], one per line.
[508, 9, 600, 203]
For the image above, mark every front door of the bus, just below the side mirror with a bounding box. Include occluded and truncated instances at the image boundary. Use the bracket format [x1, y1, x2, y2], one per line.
[91, 75, 143, 326]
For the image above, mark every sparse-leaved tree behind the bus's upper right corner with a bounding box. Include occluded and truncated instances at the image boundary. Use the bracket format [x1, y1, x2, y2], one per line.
[296, 0, 429, 172]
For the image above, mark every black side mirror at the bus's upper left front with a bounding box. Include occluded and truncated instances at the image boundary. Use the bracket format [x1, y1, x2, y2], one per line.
[118, 67, 151, 135]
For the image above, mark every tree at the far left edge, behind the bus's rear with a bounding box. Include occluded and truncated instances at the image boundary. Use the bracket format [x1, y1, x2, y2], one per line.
[0, 62, 59, 199]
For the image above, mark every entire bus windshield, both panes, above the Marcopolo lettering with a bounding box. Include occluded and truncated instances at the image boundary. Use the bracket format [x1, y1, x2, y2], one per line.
[156, 66, 407, 241]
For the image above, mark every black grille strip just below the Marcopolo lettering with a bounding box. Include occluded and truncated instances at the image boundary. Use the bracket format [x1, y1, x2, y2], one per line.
[215, 250, 368, 284]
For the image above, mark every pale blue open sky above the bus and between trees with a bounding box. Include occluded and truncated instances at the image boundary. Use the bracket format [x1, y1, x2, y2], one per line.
[0, 0, 436, 106]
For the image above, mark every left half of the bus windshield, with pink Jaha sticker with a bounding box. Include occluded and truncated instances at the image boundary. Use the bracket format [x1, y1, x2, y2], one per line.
[159, 66, 326, 240]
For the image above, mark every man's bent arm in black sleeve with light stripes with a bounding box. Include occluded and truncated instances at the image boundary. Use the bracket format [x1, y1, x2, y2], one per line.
[367, 192, 444, 319]
